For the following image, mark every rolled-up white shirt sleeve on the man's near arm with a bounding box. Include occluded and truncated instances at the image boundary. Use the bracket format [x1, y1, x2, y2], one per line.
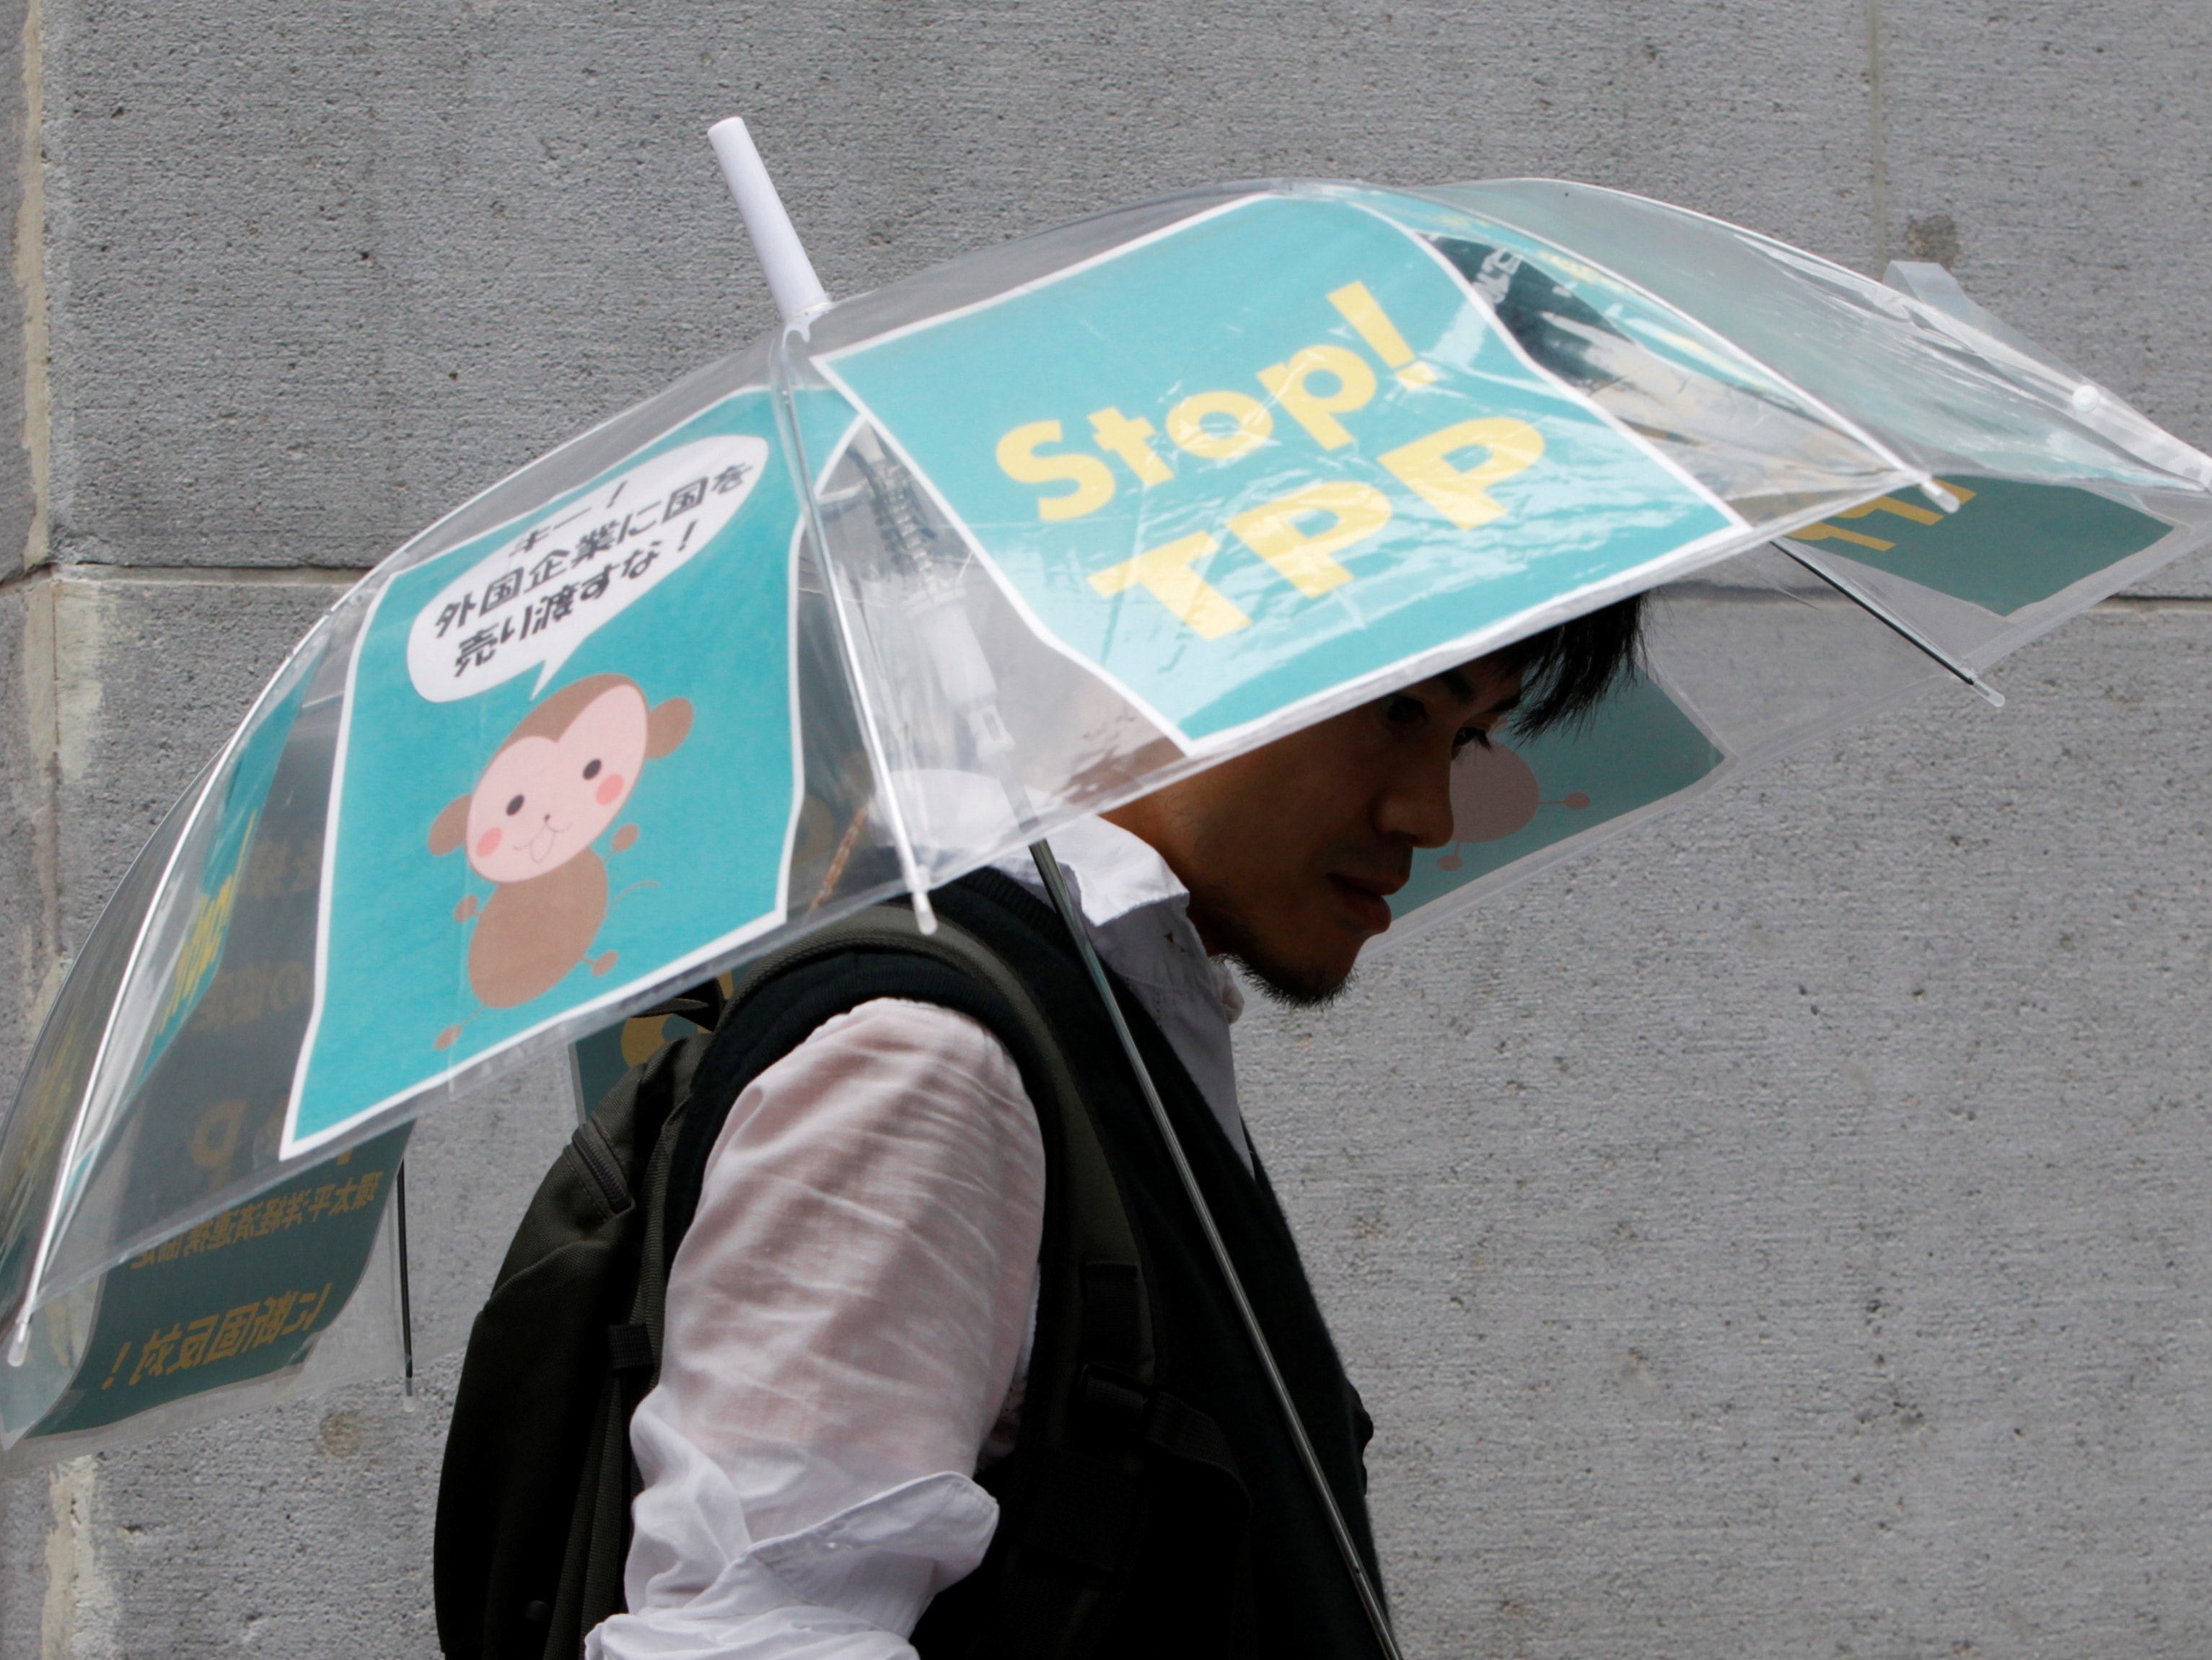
[584, 998, 1044, 1660]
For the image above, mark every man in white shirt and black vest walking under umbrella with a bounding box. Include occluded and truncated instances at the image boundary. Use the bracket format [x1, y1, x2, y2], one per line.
[586, 600, 1639, 1660]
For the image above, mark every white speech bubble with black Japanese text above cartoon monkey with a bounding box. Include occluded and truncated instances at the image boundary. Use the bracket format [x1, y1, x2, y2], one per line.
[407, 434, 768, 704]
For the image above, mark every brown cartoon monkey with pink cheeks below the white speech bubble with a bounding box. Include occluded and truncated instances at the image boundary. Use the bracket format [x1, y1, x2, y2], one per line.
[429, 675, 693, 1049]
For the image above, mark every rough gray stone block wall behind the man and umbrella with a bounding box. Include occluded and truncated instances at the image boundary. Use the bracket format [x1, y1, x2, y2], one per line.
[0, 0, 2212, 1660]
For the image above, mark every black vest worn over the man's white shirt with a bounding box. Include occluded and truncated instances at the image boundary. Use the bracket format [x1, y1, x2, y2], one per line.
[668, 870, 1380, 1660]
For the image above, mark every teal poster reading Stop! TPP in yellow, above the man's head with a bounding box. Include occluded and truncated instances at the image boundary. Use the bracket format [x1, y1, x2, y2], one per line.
[820, 197, 1741, 750]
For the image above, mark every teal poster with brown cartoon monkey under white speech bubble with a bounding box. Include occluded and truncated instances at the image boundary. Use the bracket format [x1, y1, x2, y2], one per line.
[283, 390, 801, 1158]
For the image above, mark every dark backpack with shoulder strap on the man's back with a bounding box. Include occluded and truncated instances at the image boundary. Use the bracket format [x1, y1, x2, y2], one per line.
[434, 879, 1245, 1660]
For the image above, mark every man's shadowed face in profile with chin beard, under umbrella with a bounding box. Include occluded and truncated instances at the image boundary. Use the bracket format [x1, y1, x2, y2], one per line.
[1106, 657, 1519, 1003]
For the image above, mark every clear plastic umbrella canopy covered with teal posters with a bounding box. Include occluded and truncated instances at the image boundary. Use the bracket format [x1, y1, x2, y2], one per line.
[0, 159, 2212, 1445]
